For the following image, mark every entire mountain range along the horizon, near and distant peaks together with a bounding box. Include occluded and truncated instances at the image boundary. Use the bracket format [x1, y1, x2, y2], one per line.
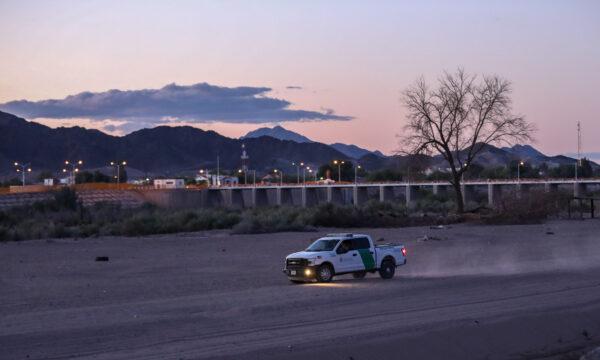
[0, 112, 598, 177]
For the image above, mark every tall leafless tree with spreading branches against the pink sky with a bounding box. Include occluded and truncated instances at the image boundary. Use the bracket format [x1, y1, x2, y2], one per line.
[401, 69, 535, 212]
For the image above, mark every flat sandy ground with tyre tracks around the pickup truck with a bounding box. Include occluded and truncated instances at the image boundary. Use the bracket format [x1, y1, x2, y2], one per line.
[0, 220, 600, 360]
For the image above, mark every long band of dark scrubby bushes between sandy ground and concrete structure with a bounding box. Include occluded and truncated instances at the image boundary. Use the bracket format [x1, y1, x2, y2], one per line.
[0, 188, 569, 241]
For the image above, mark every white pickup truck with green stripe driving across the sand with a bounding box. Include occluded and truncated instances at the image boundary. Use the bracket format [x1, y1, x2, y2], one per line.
[283, 234, 406, 283]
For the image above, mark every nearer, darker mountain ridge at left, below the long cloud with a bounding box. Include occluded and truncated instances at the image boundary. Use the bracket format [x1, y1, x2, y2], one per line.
[0, 112, 346, 175]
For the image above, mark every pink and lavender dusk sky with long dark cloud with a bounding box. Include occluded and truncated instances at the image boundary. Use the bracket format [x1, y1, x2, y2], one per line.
[0, 0, 600, 154]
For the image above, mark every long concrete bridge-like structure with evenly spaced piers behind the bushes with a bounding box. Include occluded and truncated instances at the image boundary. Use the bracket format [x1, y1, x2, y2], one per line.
[136, 181, 600, 209]
